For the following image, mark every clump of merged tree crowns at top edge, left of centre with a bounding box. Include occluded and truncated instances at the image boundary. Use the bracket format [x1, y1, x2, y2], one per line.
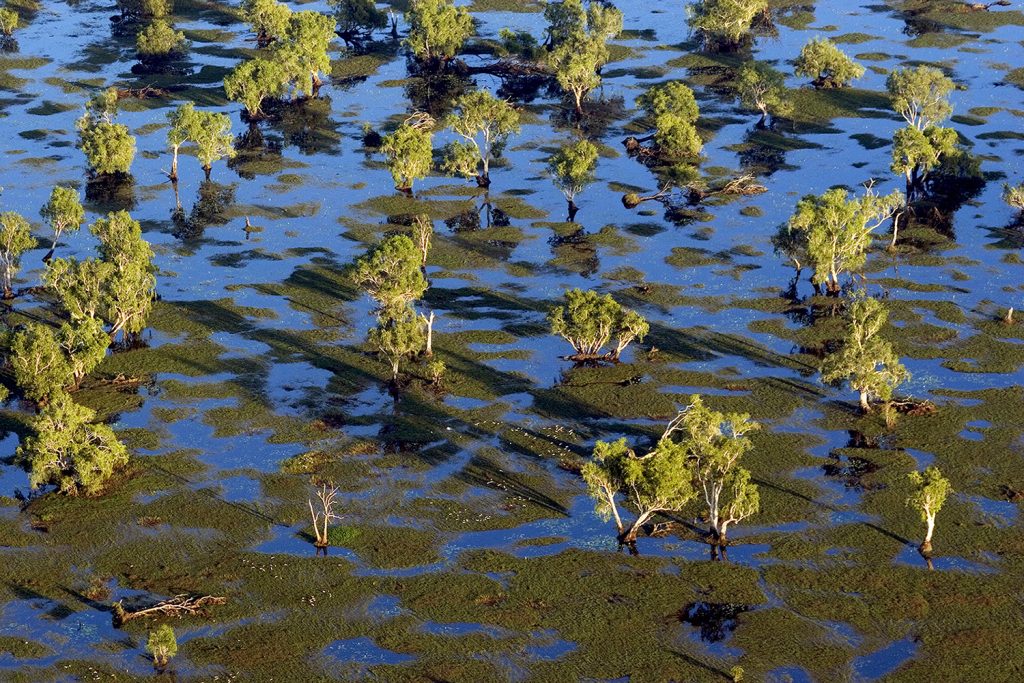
[224, 0, 335, 120]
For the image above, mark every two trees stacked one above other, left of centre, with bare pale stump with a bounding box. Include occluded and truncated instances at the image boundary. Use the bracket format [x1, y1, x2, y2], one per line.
[350, 215, 443, 385]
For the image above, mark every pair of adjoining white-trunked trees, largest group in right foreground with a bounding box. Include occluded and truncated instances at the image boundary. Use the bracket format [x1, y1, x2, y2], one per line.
[582, 395, 761, 546]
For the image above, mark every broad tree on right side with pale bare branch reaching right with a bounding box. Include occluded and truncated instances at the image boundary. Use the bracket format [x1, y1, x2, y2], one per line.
[776, 187, 905, 294]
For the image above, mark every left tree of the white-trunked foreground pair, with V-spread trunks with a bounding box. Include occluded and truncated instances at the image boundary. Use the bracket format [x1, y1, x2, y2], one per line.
[581, 435, 695, 544]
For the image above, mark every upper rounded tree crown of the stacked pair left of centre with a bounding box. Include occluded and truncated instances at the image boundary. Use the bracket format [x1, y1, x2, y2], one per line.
[351, 234, 427, 314]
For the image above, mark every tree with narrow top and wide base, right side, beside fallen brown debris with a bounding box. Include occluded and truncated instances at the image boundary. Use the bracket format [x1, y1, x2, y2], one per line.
[821, 297, 910, 413]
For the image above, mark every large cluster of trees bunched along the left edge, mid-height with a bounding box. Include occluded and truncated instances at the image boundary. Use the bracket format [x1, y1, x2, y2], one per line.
[0, 194, 156, 496]
